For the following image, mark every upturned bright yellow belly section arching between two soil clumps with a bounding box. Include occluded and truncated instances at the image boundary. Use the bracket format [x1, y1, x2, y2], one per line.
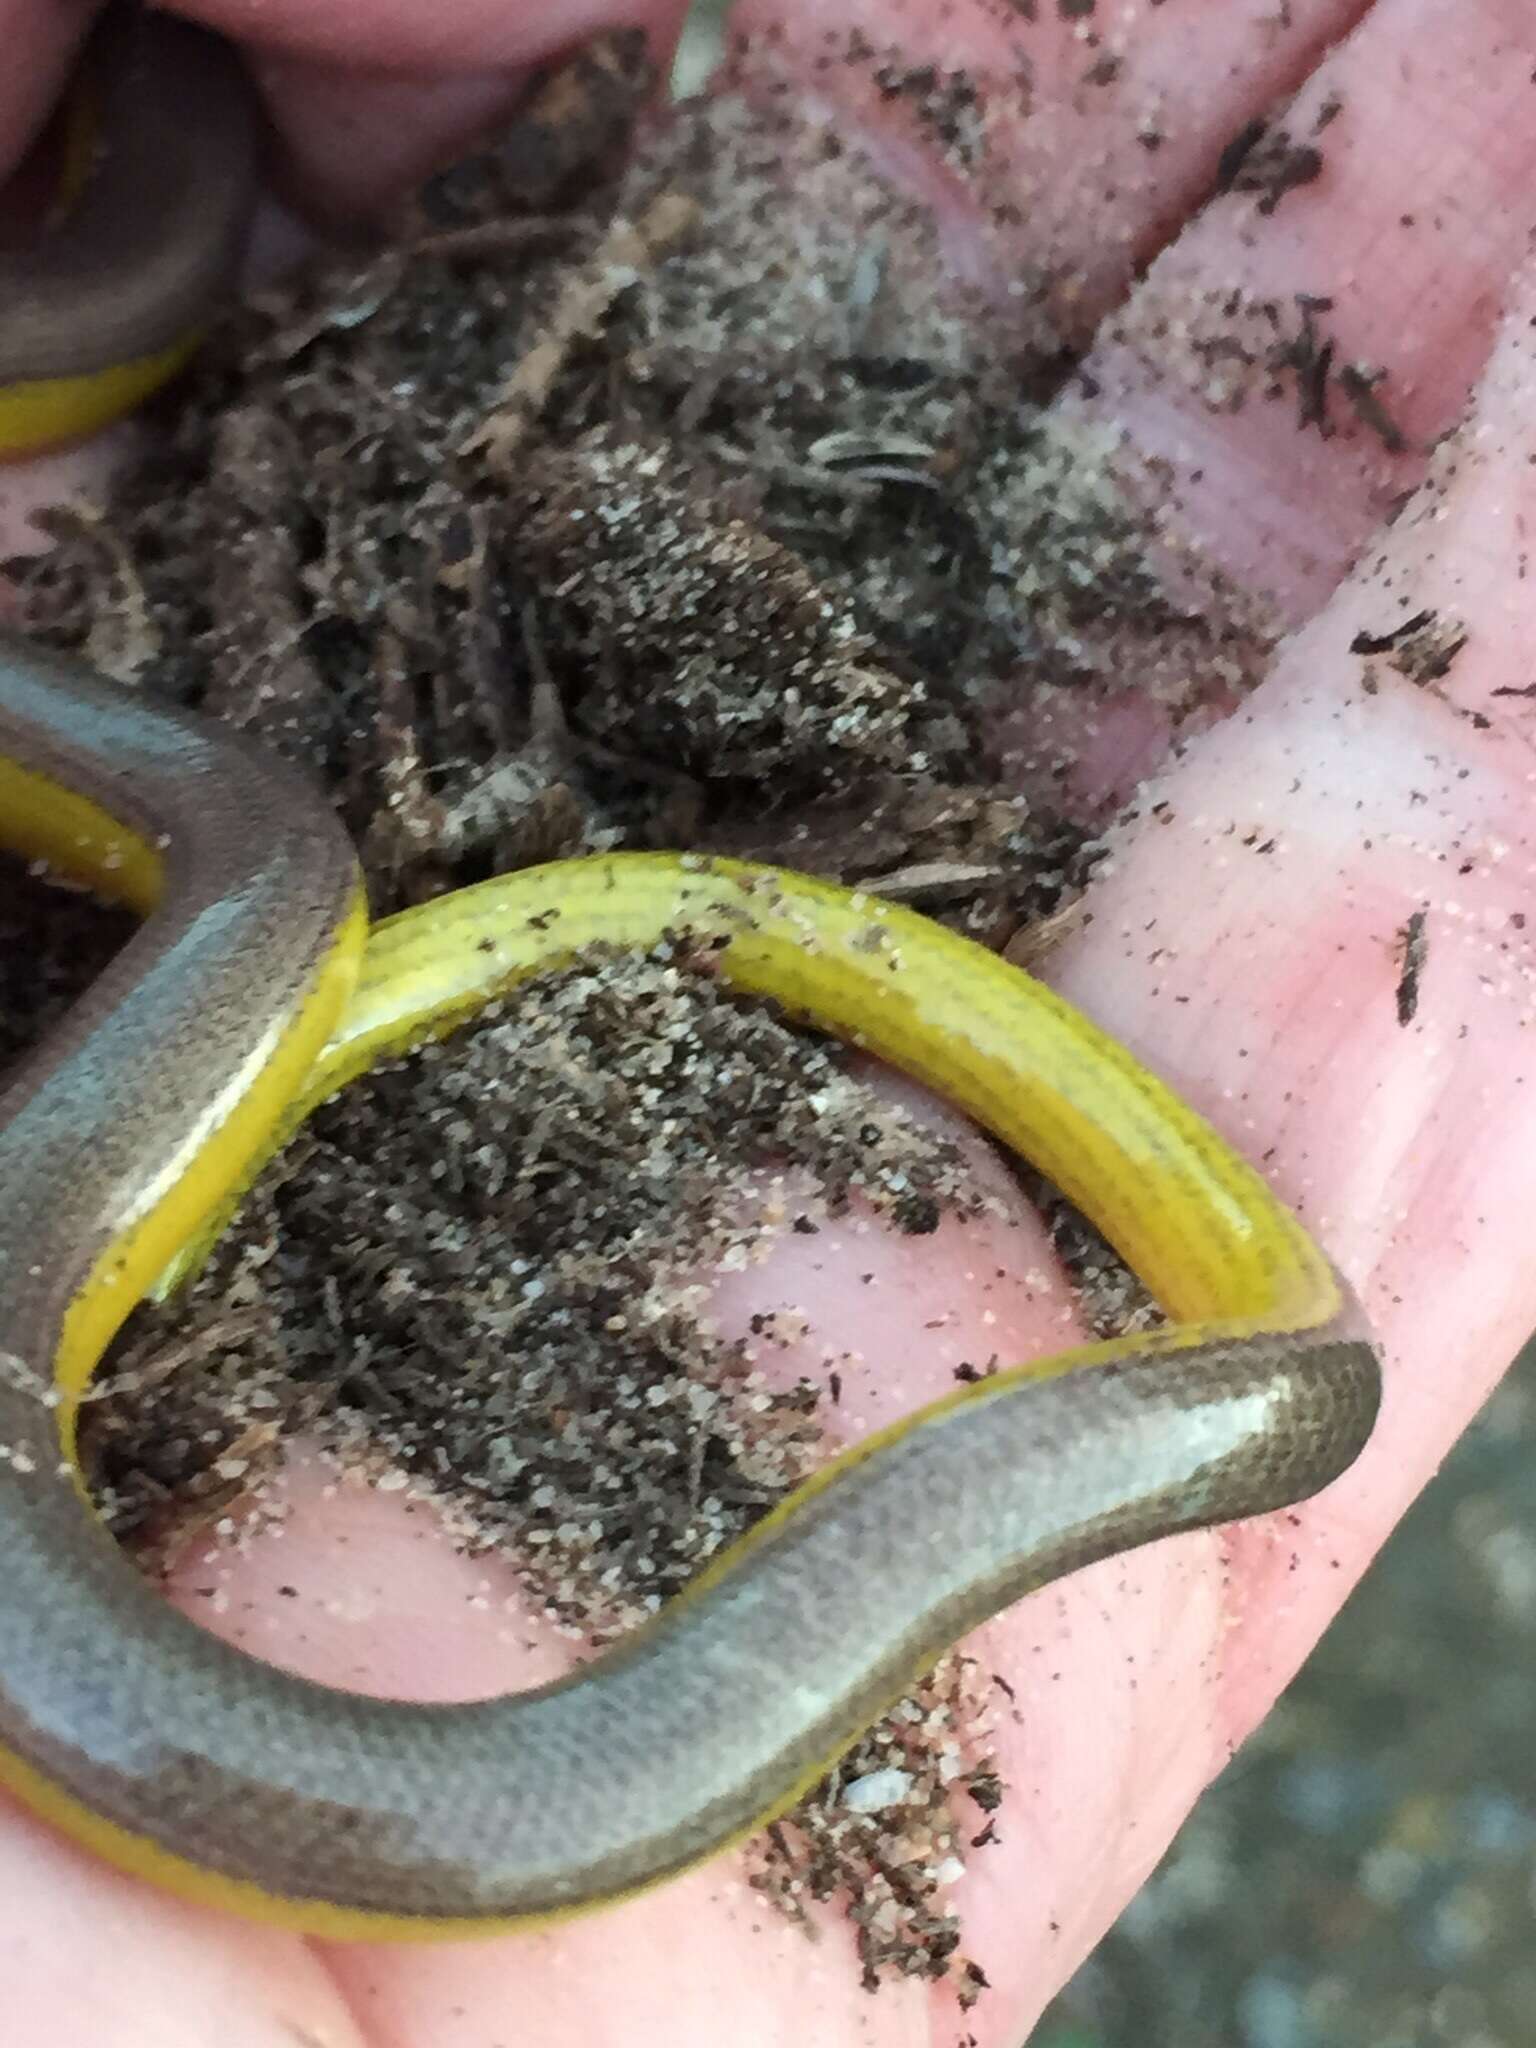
[325, 854, 1335, 1329]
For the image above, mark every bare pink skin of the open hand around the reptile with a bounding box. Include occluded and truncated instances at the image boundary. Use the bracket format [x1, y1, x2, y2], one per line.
[0, 0, 1536, 2048]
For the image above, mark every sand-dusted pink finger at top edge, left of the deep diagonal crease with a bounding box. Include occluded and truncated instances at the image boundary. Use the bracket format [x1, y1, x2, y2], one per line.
[731, 0, 1366, 339]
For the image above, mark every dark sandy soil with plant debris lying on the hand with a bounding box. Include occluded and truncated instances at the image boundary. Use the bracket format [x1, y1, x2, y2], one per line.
[0, 16, 1319, 1997]
